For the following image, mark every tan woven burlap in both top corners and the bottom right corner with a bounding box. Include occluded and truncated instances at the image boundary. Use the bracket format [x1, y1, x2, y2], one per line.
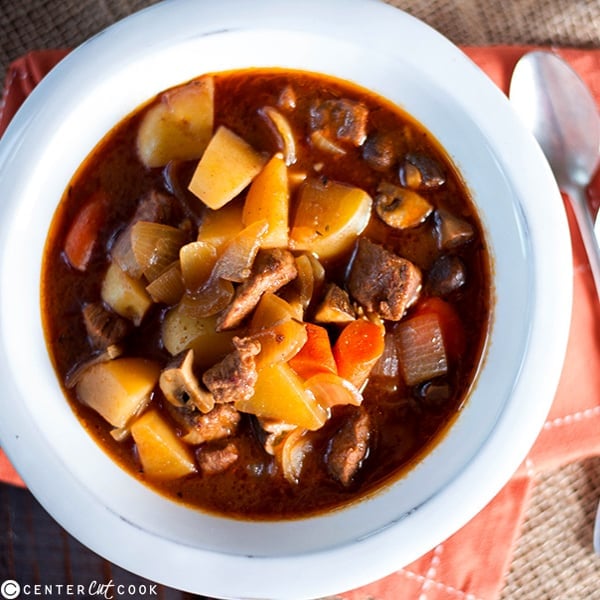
[0, 0, 600, 600]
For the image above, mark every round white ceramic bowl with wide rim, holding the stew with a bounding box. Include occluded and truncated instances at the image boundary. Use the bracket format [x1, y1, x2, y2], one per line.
[0, 0, 572, 600]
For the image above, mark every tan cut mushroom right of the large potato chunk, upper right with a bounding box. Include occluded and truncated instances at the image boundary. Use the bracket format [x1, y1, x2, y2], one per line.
[375, 182, 433, 229]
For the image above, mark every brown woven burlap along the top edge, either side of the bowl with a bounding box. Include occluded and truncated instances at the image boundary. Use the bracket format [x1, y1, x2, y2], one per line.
[0, 0, 600, 80]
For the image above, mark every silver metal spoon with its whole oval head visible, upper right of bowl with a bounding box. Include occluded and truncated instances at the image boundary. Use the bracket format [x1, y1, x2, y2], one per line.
[509, 51, 600, 298]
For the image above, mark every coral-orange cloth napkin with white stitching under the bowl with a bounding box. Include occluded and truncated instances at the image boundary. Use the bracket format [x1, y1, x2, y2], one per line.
[0, 46, 600, 600]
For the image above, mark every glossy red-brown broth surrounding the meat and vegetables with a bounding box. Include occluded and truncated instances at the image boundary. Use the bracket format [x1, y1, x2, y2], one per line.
[42, 70, 491, 519]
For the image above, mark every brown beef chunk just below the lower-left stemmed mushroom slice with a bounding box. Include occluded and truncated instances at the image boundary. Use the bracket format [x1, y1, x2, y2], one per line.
[167, 403, 241, 445]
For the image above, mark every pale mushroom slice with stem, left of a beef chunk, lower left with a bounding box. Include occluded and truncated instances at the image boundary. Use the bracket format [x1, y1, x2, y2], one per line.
[159, 348, 215, 413]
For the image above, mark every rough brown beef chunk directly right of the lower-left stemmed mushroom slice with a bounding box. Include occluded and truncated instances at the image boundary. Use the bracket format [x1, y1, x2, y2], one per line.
[202, 337, 260, 403]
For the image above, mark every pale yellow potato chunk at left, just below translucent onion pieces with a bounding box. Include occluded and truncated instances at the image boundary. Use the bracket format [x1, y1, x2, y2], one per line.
[101, 263, 152, 325]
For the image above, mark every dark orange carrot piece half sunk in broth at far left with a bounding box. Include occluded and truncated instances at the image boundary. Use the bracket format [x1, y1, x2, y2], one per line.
[64, 191, 106, 271]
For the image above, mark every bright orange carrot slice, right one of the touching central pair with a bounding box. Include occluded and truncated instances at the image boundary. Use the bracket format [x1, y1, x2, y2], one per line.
[333, 319, 385, 389]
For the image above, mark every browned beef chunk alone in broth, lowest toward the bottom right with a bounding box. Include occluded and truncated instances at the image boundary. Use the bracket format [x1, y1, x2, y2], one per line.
[327, 407, 371, 486]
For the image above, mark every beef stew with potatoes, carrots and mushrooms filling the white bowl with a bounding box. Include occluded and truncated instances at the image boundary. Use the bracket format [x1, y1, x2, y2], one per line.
[42, 69, 491, 519]
